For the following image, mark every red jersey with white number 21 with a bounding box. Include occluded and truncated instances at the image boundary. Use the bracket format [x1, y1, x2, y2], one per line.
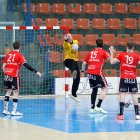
[4, 51, 26, 77]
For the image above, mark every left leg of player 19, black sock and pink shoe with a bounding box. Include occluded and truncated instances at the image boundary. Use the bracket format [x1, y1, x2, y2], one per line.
[116, 79, 128, 120]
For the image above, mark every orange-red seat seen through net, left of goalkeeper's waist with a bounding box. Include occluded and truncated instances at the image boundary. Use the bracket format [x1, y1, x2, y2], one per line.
[50, 51, 61, 63]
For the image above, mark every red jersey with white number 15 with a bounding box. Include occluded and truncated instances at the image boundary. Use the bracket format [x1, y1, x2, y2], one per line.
[84, 48, 109, 75]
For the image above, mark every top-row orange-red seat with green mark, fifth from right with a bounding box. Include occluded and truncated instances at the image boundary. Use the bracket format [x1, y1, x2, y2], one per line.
[68, 3, 82, 14]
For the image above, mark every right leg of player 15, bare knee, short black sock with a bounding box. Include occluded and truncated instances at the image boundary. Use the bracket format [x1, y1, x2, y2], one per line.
[95, 76, 108, 114]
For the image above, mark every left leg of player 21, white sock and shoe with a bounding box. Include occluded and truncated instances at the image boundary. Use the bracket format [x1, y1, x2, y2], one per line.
[3, 75, 12, 115]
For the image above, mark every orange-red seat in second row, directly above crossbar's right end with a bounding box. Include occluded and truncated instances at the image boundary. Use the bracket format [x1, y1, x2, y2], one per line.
[61, 18, 74, 29]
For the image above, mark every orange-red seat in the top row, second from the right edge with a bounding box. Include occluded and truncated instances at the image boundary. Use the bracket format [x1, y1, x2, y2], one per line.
[114, 3, 128, 14]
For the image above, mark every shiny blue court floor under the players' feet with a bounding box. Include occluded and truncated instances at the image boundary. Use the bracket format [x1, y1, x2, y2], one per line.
[0, 95, 140, 133]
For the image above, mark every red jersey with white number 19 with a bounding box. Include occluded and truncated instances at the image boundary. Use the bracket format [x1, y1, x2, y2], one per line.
[116, 52, 140, 79]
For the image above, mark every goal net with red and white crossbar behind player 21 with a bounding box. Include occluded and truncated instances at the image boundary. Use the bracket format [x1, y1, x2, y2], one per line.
[0, 24, 68, 95]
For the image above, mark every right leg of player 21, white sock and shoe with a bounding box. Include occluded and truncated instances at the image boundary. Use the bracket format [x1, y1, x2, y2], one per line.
[11, 77, 23, 116]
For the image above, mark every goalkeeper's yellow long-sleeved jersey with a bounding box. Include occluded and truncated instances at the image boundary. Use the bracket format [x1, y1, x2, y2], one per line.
[63, 40, 78, 61]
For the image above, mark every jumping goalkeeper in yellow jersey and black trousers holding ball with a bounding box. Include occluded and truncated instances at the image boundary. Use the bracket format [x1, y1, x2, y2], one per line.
[63, 33, 80, 102]
